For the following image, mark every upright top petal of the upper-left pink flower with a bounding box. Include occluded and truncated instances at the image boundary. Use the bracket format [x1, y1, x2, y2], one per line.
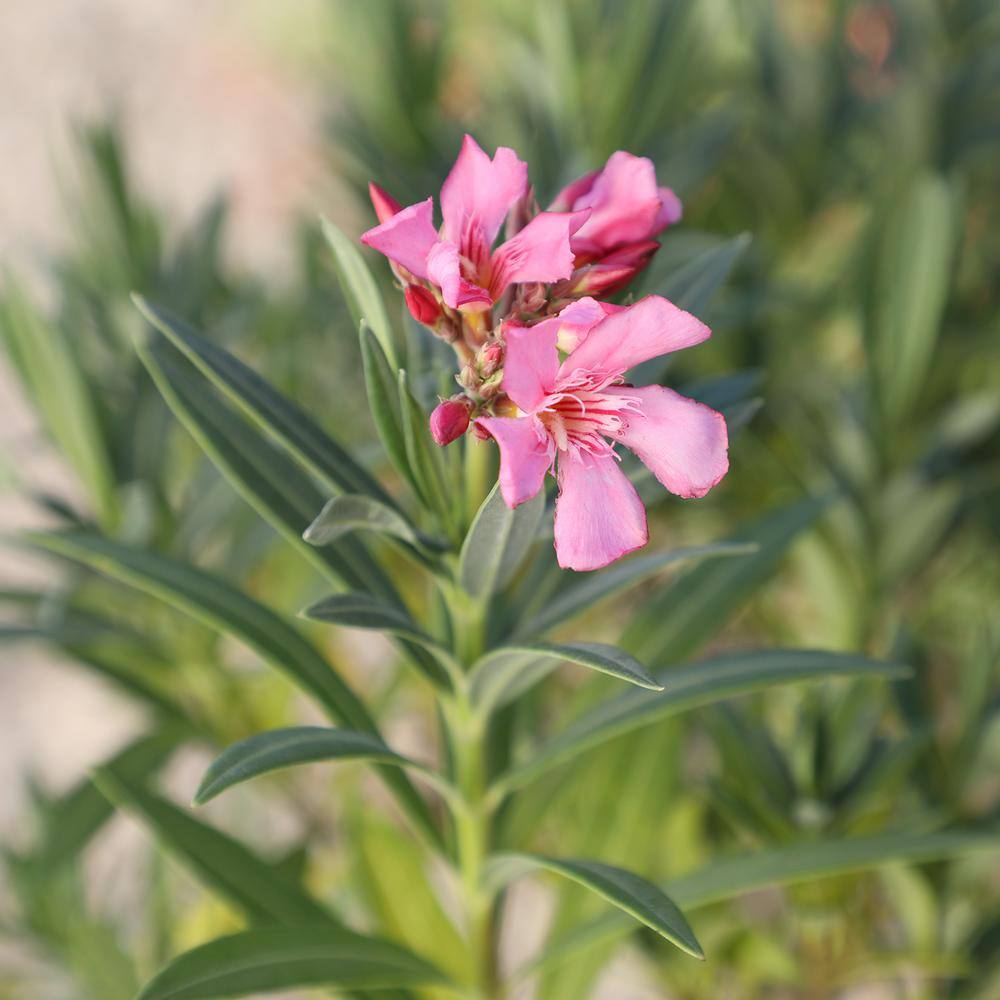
[441, 135, 528, 249]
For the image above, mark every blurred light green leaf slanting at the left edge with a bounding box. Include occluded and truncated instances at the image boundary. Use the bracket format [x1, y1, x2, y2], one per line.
[0, 280, 120, 528]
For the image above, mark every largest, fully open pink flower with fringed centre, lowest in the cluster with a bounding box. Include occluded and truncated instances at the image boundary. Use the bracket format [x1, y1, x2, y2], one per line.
[476, 295, 729, 570]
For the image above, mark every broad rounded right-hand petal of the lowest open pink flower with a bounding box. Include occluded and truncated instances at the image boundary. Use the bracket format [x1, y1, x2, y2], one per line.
[606, 385, 729, 497]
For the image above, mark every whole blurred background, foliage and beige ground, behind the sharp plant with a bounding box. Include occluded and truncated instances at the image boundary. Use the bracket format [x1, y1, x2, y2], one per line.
[0, 0, 1000, 1000]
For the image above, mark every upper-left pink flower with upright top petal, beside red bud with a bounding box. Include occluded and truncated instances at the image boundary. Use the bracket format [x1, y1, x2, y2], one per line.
[361, 135, 589, 312]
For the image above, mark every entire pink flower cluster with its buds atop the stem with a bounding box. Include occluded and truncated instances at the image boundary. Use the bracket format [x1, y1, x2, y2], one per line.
[362, 136, 728, 570]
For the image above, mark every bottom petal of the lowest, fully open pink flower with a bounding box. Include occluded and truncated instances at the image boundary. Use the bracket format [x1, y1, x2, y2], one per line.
[555, 452, 649, 570]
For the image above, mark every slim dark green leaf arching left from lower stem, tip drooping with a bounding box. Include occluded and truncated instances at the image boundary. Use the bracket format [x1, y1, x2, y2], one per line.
[194, 726, 432, 805]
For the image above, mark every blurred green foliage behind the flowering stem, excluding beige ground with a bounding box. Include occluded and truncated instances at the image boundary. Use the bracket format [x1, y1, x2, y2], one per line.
[0, 0, 1000, 1000]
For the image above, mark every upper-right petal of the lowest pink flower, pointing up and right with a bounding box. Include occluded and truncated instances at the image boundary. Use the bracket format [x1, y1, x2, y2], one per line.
[559, 295, 712, 376]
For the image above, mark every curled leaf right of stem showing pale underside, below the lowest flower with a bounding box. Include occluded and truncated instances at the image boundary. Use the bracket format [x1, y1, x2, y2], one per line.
[469, 642, 663, 709]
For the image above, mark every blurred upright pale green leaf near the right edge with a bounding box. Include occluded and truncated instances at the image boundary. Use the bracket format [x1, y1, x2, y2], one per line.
[870, 174, 956, 420]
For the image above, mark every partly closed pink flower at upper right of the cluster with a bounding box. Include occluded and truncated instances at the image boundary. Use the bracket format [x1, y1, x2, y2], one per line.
[550, 150, 681, 263]
